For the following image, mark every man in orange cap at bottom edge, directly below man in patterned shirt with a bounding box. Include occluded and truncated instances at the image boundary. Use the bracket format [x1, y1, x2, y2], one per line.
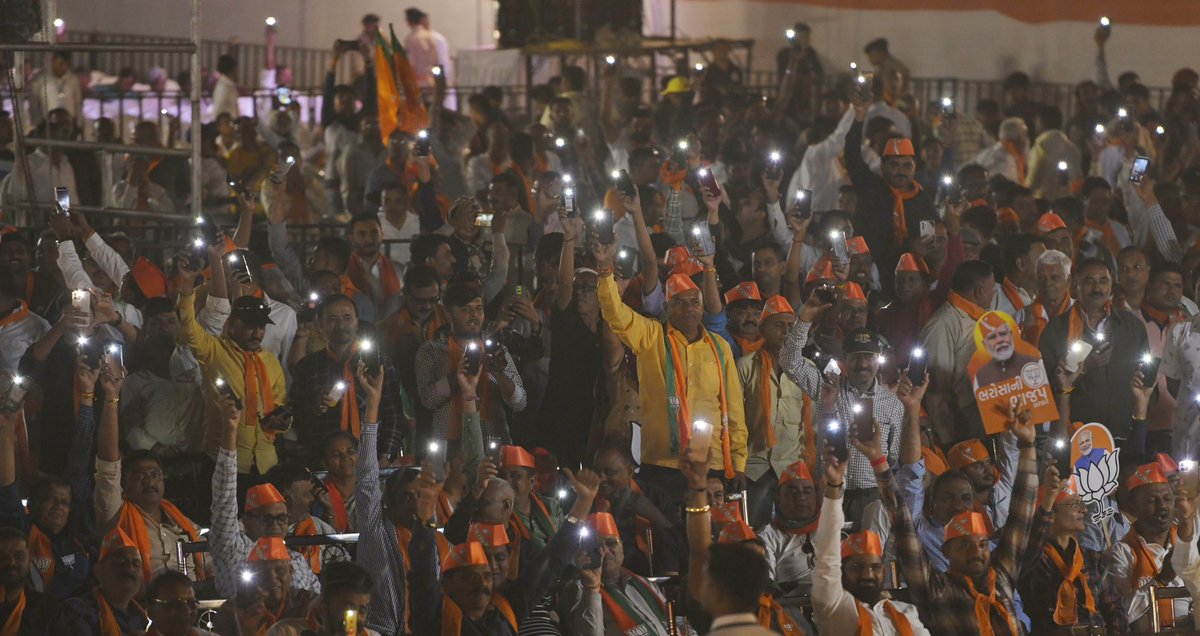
[212, 536, 317, 634]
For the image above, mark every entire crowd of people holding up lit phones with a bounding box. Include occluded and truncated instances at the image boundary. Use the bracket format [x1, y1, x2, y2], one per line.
[0, 8, 1200, 636]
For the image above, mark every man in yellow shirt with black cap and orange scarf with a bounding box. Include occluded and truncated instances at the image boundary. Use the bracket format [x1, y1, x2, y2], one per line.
[179, 272, 290, 474]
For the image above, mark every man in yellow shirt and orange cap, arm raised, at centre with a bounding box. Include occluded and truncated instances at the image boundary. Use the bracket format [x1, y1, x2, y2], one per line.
[594, 238, 746, 500]
